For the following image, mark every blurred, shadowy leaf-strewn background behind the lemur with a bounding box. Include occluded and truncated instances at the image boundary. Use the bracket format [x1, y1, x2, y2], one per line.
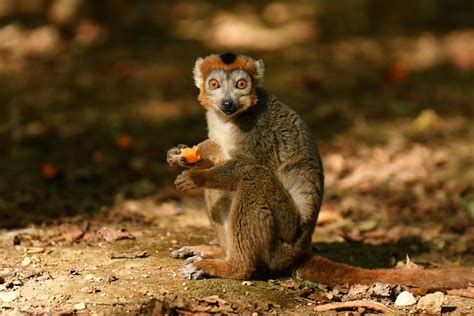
[0, 0, 474, 228]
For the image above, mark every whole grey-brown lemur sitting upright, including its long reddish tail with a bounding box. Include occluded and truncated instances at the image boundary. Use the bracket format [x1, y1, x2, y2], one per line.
[167, 53, 474, 289]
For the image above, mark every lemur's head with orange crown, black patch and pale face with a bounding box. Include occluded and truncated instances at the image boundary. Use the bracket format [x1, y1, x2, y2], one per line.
[193, 53, 264, 117]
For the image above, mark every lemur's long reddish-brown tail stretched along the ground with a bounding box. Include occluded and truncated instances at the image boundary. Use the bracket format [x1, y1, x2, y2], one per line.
[296, 256, 474, 289]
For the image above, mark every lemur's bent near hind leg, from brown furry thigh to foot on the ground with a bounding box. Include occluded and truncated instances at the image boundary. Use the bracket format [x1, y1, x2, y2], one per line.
[183, 166, 299, 279]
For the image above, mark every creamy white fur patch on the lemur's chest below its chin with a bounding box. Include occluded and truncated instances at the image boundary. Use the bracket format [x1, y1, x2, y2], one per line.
[207, 111, 238, 159]
